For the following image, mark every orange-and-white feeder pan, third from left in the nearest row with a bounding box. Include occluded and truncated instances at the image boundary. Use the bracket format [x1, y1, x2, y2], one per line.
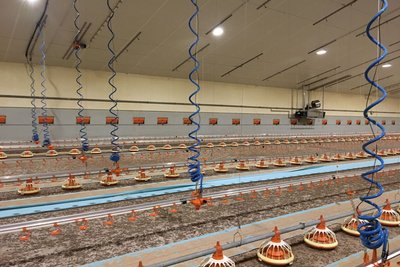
[304, 215, 338, 249]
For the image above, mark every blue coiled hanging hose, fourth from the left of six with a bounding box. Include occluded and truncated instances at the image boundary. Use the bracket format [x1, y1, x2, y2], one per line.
[107, 0, 120, 163]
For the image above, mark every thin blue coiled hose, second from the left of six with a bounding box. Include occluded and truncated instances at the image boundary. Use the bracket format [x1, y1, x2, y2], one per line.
[40, 32, 51, 147]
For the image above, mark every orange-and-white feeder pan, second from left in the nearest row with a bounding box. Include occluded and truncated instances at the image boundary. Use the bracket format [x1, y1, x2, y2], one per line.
[257, 226, 294, 266]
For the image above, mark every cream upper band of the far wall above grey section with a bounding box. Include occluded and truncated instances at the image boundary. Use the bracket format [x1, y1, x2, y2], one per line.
[0, 62, 400, 117]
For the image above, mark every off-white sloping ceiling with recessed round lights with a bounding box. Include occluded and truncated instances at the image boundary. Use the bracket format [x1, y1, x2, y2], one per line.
[0, 0, 400, 95]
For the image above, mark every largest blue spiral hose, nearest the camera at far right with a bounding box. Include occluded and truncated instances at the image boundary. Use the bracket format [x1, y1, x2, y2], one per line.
[358, 0, 388, 260]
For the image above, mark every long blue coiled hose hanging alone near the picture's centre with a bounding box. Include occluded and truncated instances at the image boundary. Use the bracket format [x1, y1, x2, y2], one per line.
[188, 0, 203, 193]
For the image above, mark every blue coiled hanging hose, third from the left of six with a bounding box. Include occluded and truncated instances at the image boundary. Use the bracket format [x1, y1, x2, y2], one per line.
[73, 0, 89, 152]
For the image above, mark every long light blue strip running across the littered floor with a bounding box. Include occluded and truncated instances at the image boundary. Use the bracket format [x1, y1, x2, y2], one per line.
[0, 157, 400, 218]
